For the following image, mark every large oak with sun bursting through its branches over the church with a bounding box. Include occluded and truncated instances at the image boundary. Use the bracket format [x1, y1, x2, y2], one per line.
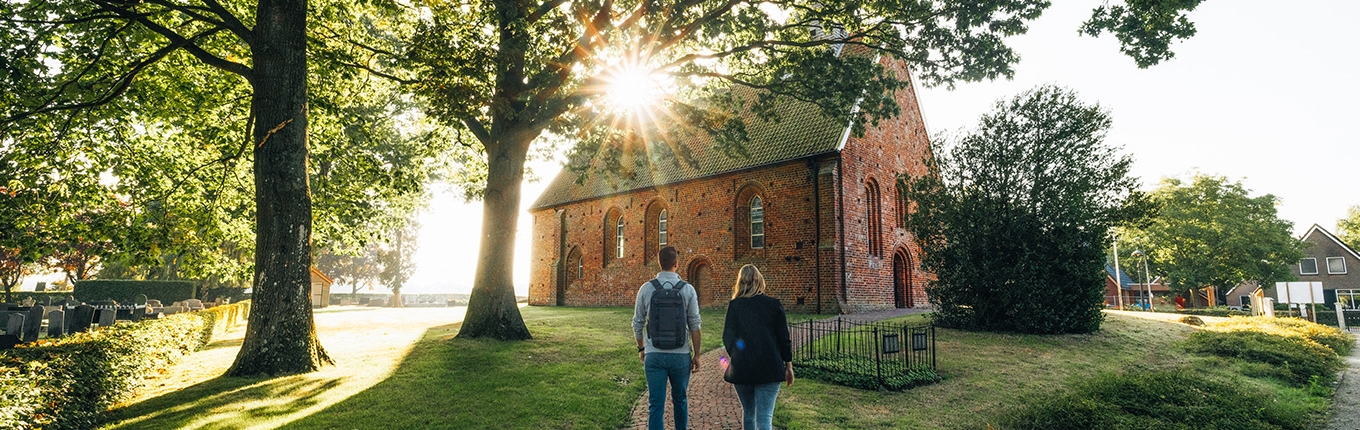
[388, 0, 1201, 339]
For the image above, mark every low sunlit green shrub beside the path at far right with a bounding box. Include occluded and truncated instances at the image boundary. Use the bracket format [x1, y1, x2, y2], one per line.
[1186, 331, 1342, 385]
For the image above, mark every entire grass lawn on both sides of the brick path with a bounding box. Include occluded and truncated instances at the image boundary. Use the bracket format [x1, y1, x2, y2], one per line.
[100, 306, 1330, 429]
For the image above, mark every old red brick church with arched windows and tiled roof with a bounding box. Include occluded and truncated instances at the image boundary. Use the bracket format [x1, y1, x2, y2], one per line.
[529, 57, 932, 313]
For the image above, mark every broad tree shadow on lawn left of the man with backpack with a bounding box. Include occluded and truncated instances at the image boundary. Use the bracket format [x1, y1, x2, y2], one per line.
[284, 310, 643, 429]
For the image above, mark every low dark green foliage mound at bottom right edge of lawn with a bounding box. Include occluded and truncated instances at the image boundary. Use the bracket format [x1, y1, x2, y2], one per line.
[1001, 369, 1308, 430]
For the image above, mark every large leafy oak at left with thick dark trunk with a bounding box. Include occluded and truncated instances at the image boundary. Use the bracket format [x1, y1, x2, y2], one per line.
[0, 0, 447, 376]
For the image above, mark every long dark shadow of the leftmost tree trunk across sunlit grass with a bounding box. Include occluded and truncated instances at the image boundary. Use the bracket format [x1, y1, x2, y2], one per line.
[105, 376, 345, 429]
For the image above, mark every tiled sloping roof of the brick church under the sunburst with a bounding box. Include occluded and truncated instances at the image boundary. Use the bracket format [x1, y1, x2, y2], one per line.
[529, 87, 850, 210]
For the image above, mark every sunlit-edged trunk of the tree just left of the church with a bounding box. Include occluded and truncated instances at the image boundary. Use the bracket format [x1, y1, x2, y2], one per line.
[458, 139, 533, 340]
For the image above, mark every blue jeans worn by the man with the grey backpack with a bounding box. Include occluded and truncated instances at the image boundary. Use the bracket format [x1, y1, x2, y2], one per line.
[643, 352, 690, 430]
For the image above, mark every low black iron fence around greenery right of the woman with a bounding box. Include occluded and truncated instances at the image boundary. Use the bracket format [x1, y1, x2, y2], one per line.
[789, 317, 940, 389]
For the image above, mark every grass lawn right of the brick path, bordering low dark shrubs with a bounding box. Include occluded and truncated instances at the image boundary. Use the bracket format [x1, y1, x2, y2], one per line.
[775, 313, 1330, 429]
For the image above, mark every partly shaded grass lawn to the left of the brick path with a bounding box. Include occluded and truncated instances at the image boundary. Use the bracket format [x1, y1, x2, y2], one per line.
[109, 306, 734, 429]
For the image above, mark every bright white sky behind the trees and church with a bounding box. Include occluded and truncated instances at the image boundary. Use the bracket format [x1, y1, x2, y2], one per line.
[407, 0, 1360, 294]
